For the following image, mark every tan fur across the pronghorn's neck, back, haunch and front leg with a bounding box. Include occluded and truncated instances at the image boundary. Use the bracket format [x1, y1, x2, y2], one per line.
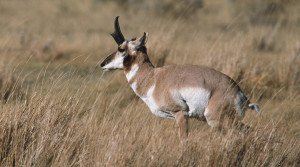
[125, 48, 246, 140]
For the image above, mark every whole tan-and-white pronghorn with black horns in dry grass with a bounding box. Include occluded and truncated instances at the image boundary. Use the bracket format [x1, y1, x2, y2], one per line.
[101, 17, 259, 143]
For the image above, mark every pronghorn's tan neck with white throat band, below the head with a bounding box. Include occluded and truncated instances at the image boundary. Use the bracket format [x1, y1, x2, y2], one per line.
[124, 53, 154, 95]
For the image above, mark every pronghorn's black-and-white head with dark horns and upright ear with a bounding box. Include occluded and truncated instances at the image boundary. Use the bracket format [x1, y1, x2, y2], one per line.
[100, 16, 149, 71]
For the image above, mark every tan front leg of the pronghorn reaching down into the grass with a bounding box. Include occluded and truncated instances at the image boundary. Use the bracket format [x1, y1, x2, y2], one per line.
[175, 111, 188, 145]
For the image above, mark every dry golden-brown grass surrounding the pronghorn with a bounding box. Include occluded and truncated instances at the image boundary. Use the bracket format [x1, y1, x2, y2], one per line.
[0, 0, 300, 166]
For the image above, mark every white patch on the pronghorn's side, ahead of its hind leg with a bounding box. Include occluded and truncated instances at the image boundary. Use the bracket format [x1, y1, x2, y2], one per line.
[172, 88, 210, 118]
